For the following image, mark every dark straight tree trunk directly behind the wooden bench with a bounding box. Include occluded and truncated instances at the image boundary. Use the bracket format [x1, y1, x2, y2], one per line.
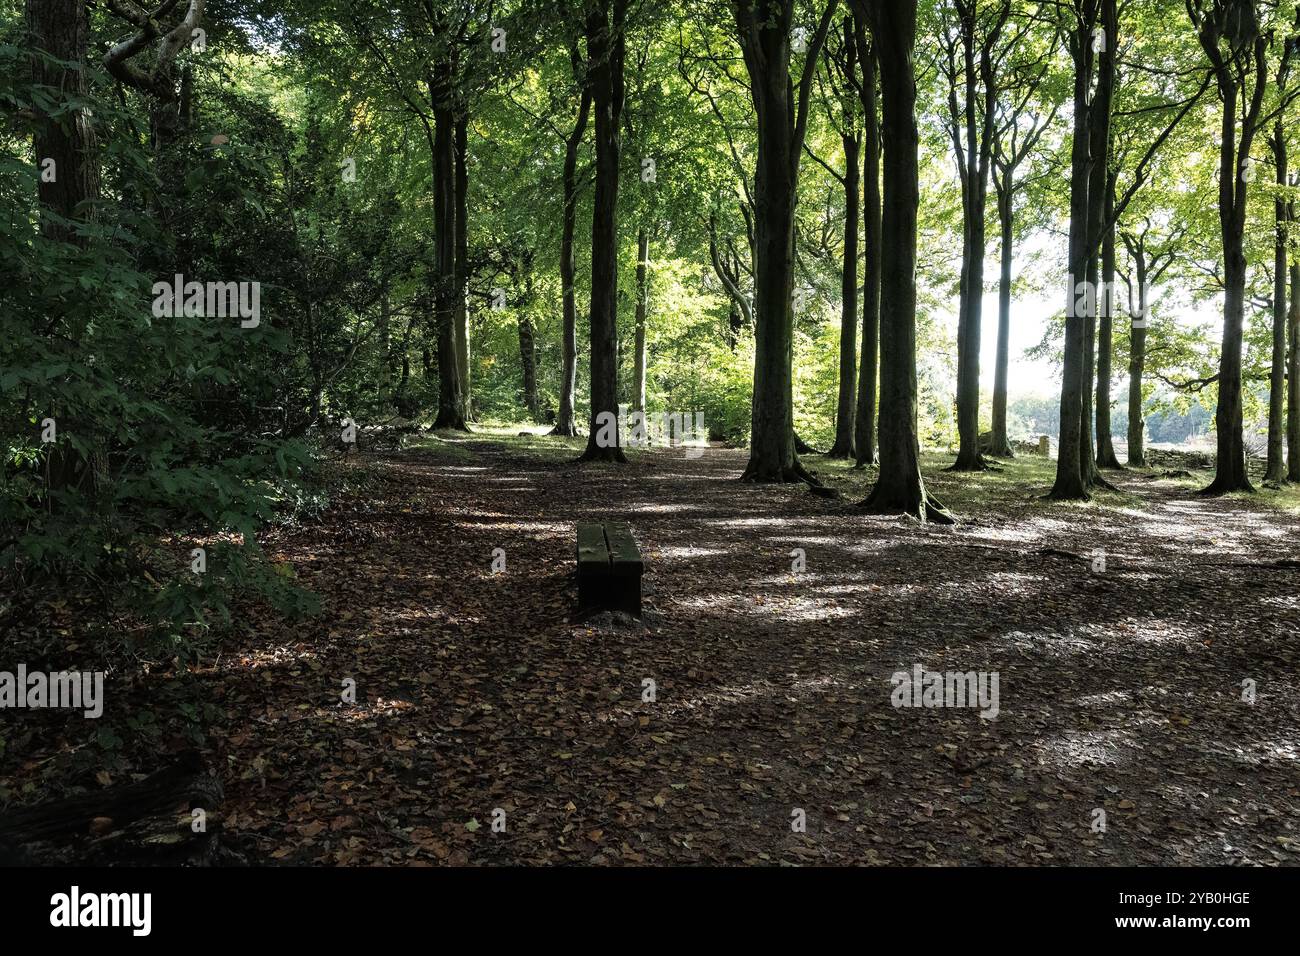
[581, 0, 628, 462]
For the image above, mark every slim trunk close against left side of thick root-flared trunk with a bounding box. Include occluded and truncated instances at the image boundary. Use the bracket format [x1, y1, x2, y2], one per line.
[853, 22, 881, 468]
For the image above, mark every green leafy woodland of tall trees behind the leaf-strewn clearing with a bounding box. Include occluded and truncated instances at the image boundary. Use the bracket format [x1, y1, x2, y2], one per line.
[0, 0, 1300, 860]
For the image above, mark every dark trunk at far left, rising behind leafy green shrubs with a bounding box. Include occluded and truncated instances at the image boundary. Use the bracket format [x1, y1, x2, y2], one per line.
[26, 0, 99, 245]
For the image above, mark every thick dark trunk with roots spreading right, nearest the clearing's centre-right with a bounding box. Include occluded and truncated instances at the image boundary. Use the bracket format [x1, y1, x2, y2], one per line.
[855, 0, 953, 523]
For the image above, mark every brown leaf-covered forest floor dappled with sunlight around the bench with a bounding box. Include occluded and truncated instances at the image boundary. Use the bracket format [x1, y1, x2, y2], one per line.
[2, 429, 1300, 865]
